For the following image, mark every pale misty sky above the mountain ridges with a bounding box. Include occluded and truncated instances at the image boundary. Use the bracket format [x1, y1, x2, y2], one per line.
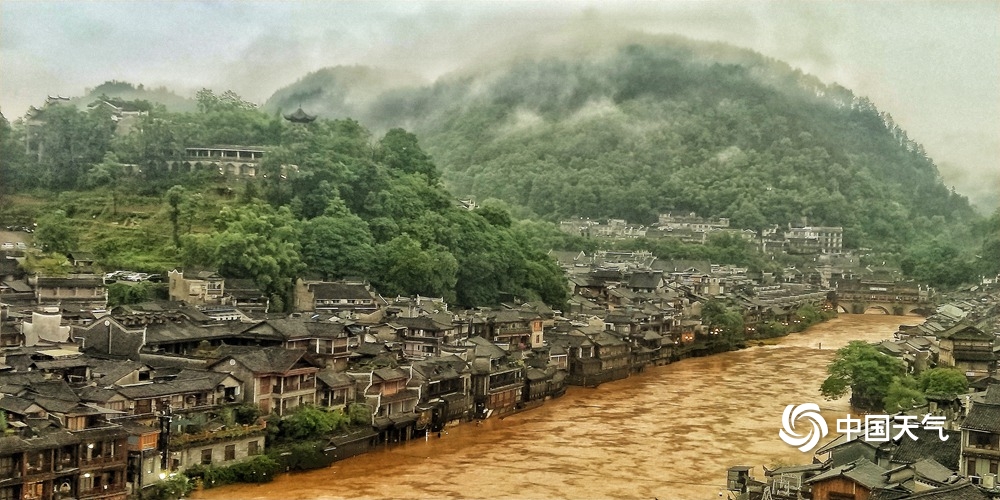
[0, 0, 1000, 211]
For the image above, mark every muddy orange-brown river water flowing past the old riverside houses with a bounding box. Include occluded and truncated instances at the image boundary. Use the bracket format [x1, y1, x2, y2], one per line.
[194, 315, 922, 500]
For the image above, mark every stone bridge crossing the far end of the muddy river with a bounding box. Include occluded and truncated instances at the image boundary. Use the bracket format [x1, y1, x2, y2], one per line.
[834, 280, 935, 316]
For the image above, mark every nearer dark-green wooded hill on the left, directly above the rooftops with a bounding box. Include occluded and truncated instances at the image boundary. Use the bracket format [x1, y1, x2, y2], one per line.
[0, 89, 567, 311]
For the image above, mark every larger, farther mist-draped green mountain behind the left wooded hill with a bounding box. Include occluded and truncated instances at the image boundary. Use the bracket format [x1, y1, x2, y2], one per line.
[267, 38, 973, 252]
